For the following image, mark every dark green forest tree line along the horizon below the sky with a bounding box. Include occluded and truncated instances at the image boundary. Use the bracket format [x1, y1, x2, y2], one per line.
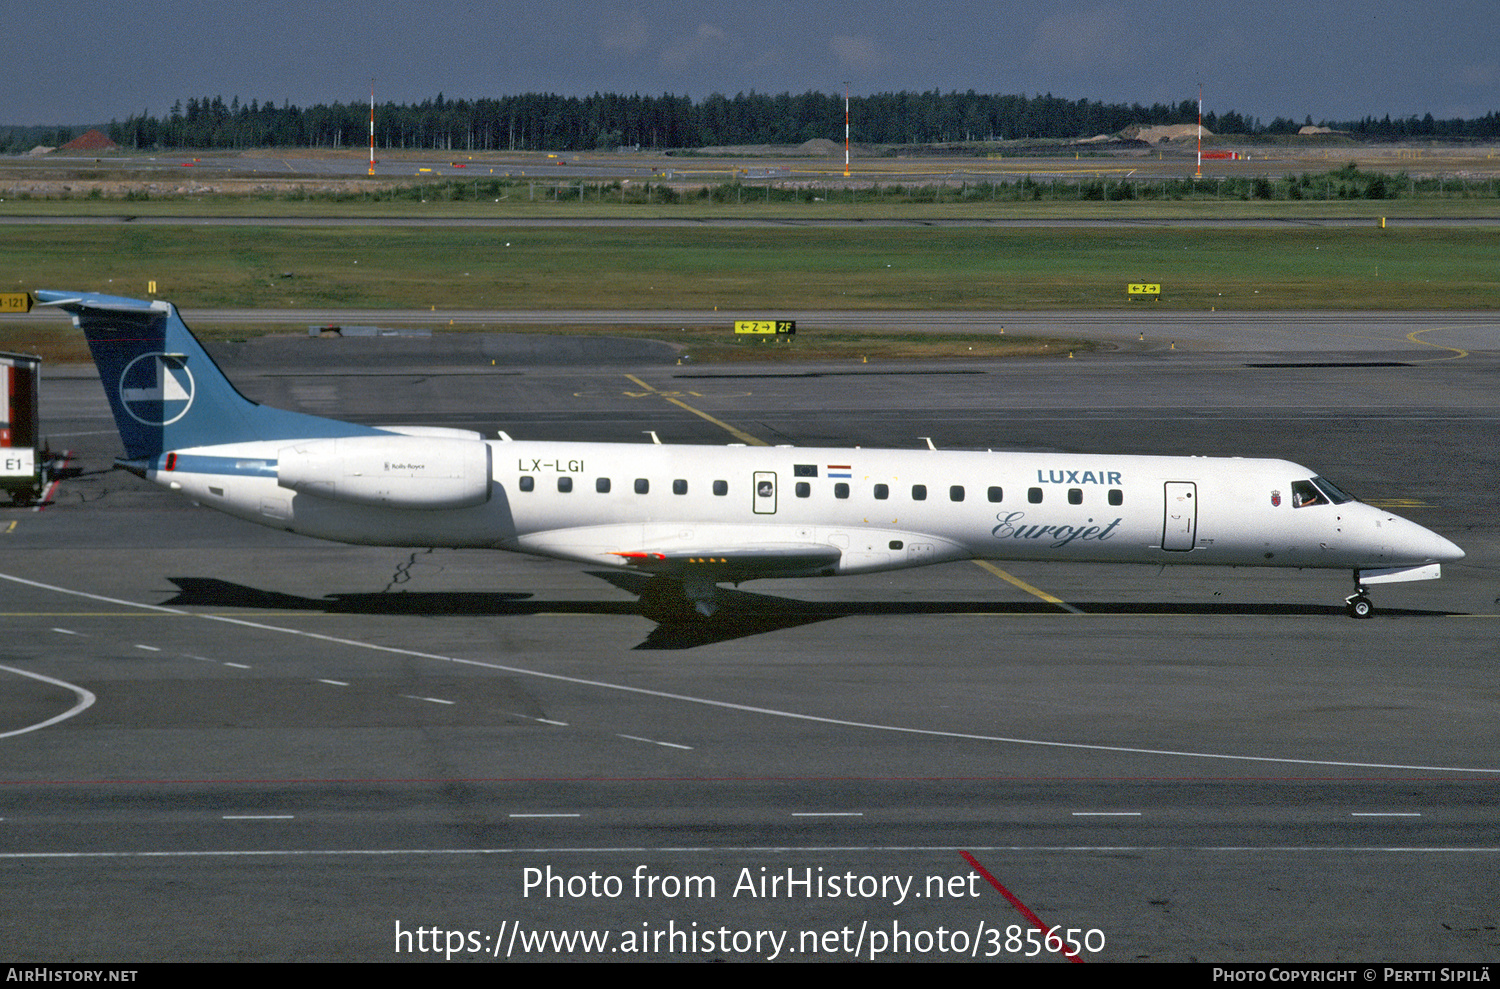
[0, 90, 1500, 153]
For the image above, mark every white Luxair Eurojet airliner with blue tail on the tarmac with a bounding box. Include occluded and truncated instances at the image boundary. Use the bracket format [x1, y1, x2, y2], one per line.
[38, 291, 1464, 621]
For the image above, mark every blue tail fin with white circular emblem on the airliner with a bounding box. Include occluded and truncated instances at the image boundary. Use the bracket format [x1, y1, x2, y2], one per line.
[36, 291, 378, 462]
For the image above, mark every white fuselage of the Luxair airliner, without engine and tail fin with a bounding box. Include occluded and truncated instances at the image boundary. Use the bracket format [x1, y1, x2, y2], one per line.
[147, 438, 1463, 579]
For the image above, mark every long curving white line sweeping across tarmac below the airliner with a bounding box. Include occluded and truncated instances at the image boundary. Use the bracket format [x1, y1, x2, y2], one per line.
[0, 573, 1500, 776]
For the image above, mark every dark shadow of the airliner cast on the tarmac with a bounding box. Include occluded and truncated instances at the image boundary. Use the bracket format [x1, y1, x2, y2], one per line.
[164, 572, 1448, 650]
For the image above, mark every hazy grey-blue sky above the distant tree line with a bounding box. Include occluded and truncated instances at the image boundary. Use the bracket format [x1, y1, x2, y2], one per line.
[0, 0, 1500, 125]
